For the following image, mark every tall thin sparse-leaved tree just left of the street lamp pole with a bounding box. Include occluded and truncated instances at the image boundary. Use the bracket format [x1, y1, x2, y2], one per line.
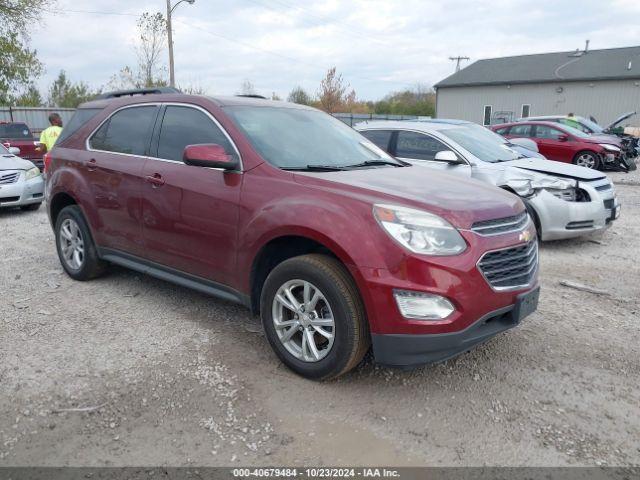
[136, 12, 167, 87]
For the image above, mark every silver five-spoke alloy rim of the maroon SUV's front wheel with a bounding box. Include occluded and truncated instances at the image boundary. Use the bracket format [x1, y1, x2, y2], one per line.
[272, 280, 335, 362]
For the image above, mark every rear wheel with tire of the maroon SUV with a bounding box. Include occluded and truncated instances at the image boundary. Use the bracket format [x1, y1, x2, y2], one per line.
[55, 205, 106, 280]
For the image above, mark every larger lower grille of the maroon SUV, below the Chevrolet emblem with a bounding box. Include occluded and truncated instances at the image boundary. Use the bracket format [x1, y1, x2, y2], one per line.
[478, 240, 538, 290]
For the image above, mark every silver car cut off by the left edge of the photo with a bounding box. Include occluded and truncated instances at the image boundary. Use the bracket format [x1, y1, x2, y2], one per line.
[0, 144, 44, 210]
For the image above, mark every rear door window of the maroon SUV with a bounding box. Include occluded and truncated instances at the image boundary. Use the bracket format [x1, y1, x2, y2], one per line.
[89, 106, 158, 155]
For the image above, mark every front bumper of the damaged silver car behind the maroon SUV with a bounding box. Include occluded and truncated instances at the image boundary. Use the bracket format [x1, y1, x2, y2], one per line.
[528, 182, 620, 241]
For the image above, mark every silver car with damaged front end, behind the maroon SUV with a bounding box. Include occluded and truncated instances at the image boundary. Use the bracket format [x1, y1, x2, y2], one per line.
[355, 119, 620, 240]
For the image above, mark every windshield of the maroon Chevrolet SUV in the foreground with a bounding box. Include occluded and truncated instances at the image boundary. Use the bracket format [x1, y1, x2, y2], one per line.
[225, 106, 403, 170]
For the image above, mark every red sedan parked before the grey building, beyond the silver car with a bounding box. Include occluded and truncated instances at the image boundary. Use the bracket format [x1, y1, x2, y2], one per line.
[490, 122, 621, 169]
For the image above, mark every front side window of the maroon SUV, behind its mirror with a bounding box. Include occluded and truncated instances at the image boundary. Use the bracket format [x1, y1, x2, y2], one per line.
[157, 105, 235, 162]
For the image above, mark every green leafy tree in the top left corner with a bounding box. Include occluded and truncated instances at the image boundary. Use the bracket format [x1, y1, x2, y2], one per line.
[0, 0, 53, 104]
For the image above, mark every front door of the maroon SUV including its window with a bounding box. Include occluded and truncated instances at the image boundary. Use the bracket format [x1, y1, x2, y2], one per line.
[143, 104, 242, 285]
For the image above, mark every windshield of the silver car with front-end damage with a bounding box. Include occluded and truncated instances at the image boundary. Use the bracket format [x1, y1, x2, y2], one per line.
[440, 124, 524, 163]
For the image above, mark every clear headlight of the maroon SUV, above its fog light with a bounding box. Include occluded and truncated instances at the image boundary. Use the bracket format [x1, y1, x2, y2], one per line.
[373, 205, 467, 255]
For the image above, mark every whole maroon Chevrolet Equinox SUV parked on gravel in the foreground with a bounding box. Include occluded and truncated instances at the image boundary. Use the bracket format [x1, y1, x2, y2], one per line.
[47, 90, 539, 379]
